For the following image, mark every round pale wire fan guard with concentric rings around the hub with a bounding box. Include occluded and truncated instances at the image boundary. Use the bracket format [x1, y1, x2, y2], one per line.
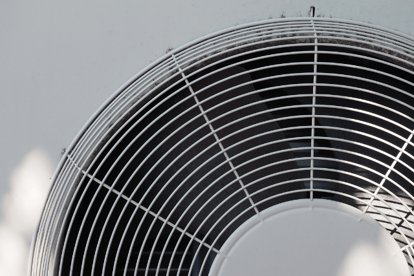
[30, 18, 414, 275]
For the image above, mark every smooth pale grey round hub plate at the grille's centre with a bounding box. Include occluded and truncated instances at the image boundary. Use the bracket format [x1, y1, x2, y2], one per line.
[211, 199, 410, 276]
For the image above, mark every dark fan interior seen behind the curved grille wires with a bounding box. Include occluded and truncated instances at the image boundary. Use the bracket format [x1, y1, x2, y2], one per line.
[59, 44, 414, 275]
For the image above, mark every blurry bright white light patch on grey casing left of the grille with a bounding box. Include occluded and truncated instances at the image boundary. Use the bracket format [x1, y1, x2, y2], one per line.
[0, 149, 53, 276]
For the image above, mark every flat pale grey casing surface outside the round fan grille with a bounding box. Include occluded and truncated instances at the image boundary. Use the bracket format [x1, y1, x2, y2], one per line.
[0, 0, 414, 276]
